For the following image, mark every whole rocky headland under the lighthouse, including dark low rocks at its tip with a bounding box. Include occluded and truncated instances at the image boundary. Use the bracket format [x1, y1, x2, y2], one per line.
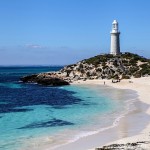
[21, 52, 150, 86]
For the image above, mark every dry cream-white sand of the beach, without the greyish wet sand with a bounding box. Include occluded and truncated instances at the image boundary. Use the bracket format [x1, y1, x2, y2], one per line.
[74, 77, 150, 149]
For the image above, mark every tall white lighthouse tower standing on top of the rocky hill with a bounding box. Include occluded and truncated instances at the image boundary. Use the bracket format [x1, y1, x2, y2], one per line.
[110, 20, 120, 55]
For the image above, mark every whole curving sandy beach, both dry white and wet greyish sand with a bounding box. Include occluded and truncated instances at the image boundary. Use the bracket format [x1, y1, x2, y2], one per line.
[54, 77, 150, 150]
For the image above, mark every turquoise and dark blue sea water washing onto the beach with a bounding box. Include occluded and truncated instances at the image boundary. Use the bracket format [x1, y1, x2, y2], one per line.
[0, 66, 135, 150]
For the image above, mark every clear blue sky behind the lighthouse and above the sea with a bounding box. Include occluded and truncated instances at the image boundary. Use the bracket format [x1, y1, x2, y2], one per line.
[0, 0, 150, 65]
